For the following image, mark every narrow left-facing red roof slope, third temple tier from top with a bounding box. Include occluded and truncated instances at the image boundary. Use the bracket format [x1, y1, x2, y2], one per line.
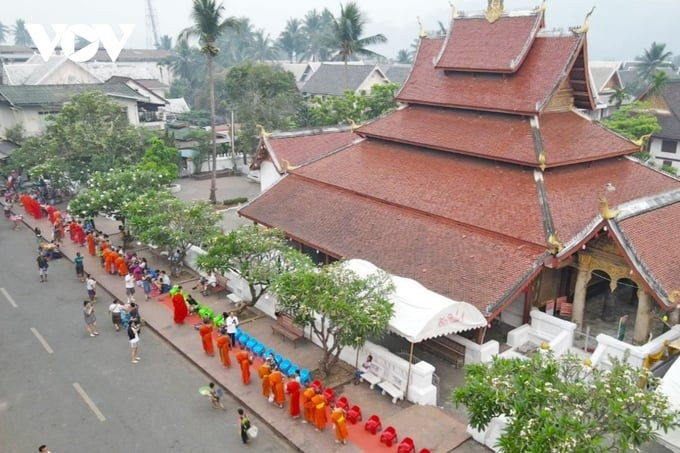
[356, 106, 537, 166]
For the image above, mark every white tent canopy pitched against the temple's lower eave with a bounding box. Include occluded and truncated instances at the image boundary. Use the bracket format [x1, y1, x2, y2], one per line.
[346, 259, 487, 343]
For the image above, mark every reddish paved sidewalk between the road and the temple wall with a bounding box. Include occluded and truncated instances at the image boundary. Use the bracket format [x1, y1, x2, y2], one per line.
[16, 208, 472, 453]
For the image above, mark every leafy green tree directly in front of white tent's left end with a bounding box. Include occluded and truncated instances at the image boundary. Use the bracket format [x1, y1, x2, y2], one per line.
[272, 262, 394, 374]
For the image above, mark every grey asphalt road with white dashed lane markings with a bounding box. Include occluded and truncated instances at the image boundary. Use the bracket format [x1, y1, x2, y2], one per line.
[0, 220, 293, 453]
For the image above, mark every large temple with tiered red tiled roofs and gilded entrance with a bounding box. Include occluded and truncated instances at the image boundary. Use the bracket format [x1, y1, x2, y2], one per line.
[240, 0, 680, 343]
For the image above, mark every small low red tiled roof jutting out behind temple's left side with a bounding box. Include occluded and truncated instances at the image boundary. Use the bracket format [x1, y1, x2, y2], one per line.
[267, 131, 359, 172]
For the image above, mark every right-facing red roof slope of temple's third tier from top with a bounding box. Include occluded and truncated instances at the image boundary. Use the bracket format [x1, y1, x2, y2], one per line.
[539, 112, 639, 168]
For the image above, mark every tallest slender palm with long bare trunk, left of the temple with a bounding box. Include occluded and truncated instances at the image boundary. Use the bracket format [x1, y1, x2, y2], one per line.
[181, 0, 238, 203]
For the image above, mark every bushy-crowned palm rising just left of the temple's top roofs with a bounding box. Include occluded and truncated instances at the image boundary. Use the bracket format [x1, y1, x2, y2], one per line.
[331, 2, 387, 64]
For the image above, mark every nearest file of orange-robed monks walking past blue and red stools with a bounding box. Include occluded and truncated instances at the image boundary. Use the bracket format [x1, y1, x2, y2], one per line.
[198, 319, 349, 444]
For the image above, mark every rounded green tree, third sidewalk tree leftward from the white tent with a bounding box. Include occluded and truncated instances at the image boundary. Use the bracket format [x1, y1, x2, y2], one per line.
[123, 191, 222, 262]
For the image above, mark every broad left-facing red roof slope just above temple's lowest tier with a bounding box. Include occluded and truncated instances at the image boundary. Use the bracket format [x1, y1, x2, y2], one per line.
[294, 140, 546, 245]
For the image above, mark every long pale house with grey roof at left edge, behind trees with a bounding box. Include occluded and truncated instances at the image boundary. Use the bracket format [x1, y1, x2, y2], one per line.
[0, 83, 150, 135]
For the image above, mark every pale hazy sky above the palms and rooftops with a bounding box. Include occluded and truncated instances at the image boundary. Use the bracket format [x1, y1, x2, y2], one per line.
[0, 0, 680, 60]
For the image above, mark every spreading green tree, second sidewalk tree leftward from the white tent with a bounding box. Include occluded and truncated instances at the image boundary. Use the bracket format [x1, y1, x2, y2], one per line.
[197, 225, 313, 309]
